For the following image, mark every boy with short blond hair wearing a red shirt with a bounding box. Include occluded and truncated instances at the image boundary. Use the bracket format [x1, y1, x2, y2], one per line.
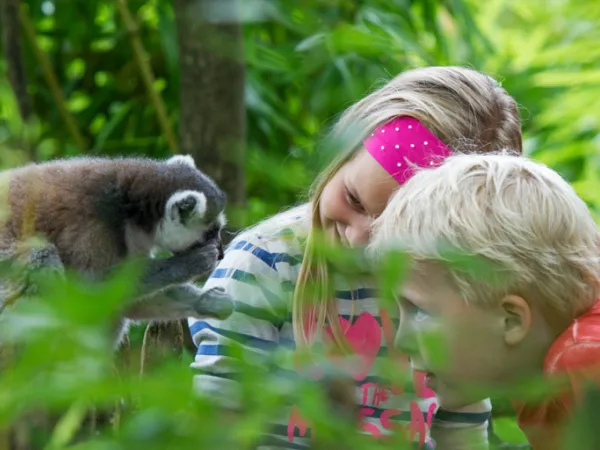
[369, 153, 600, 450]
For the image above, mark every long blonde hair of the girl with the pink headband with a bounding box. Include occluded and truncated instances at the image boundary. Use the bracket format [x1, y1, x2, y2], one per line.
[292, 67, 522, 349]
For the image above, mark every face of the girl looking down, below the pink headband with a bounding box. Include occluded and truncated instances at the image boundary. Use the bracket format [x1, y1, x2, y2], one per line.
[319, 149, 398, 247]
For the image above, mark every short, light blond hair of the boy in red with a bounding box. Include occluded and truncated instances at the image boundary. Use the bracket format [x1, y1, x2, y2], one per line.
[368, 152, 600, 317]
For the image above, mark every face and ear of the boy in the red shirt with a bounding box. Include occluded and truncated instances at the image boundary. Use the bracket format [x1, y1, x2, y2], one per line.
[395, 264, 528, 408]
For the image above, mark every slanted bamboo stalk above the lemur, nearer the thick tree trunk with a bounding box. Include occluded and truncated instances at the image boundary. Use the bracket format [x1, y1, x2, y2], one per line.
[117, 0, 179, 154]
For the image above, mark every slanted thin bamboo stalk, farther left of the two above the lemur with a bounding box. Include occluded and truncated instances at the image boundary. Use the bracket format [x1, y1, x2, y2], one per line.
[19, 4, 86, 153]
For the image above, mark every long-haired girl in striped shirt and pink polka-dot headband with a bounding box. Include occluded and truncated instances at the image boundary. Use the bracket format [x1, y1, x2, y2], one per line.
[189, 67, 522, 449]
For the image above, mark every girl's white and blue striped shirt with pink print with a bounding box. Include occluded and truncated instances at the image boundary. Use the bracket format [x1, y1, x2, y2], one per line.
[189, 205, 491, 450]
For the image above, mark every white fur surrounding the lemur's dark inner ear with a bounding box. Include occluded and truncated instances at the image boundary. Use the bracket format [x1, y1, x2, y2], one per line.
[156, 191, 206, 252]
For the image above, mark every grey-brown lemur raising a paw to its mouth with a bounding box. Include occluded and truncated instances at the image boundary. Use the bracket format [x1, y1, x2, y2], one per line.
[0, 156, 233, 342]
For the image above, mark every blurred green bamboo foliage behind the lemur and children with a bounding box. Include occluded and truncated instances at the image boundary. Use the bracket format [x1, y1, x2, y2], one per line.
[0, 0, 600, 223]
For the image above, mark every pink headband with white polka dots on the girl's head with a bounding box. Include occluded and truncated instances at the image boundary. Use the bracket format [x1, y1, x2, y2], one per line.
[363, 116, 452, 184]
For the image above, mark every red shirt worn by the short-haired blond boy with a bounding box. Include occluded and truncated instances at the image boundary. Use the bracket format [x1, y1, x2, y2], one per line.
[513, 301, 600, 450]
